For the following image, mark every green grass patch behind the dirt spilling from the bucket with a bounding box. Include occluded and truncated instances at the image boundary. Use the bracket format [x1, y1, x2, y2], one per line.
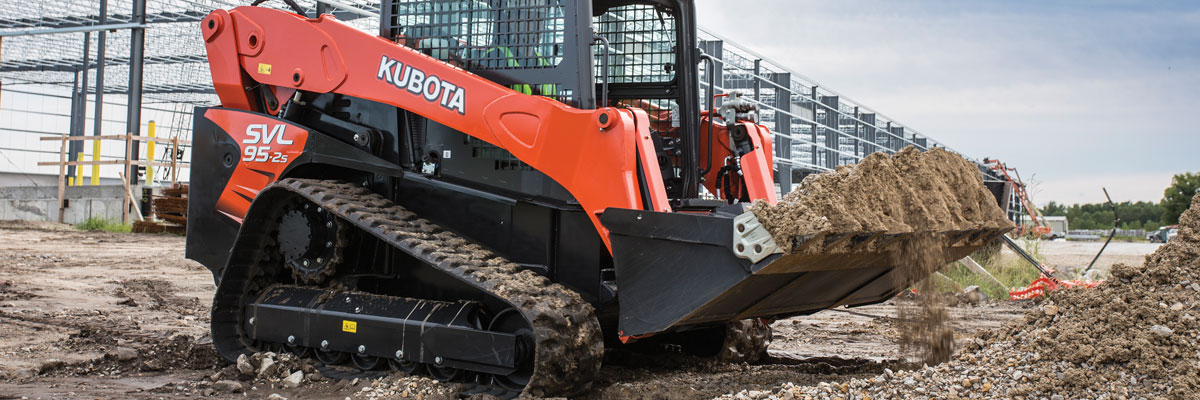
[934, 240, 1045, 299]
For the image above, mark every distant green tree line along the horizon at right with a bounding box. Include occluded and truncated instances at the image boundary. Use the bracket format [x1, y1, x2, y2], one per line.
[1042, 173, 1200, 231]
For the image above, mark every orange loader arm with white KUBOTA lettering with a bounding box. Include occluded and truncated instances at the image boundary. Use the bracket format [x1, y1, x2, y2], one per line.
[202, 7, 671, 252]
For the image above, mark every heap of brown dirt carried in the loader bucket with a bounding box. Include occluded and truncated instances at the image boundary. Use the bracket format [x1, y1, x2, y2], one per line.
[751, 147, 1010, 251]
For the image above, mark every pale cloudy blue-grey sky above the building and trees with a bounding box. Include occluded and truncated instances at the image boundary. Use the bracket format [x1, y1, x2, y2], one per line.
[696, 0, 1200, 204]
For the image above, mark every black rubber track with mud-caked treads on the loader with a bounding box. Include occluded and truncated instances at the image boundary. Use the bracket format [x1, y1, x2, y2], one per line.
[212, 179, 604, 396]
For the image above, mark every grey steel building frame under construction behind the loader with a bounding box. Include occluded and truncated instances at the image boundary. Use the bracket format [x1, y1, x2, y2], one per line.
[0, 0, 1000, 209]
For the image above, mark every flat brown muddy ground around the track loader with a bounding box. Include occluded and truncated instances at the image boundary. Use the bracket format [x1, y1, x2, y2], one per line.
[0, 222, 1142, 399]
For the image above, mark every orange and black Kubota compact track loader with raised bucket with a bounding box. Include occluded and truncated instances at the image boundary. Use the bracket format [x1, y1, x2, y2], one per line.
[187, 0, 1002, 395]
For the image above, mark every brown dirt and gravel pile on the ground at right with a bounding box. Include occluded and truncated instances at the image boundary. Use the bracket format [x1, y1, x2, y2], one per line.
[726, 195, 1200, 399]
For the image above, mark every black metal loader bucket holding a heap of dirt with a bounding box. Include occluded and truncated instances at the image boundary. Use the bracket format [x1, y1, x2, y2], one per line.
[600, 204, 1009, 338]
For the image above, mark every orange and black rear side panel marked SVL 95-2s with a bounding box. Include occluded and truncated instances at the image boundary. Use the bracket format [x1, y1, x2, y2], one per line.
[186, 107, 402, 279]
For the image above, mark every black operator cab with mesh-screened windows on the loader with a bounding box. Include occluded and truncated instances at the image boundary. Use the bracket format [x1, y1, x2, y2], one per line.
[380, 0, 701, 199]
